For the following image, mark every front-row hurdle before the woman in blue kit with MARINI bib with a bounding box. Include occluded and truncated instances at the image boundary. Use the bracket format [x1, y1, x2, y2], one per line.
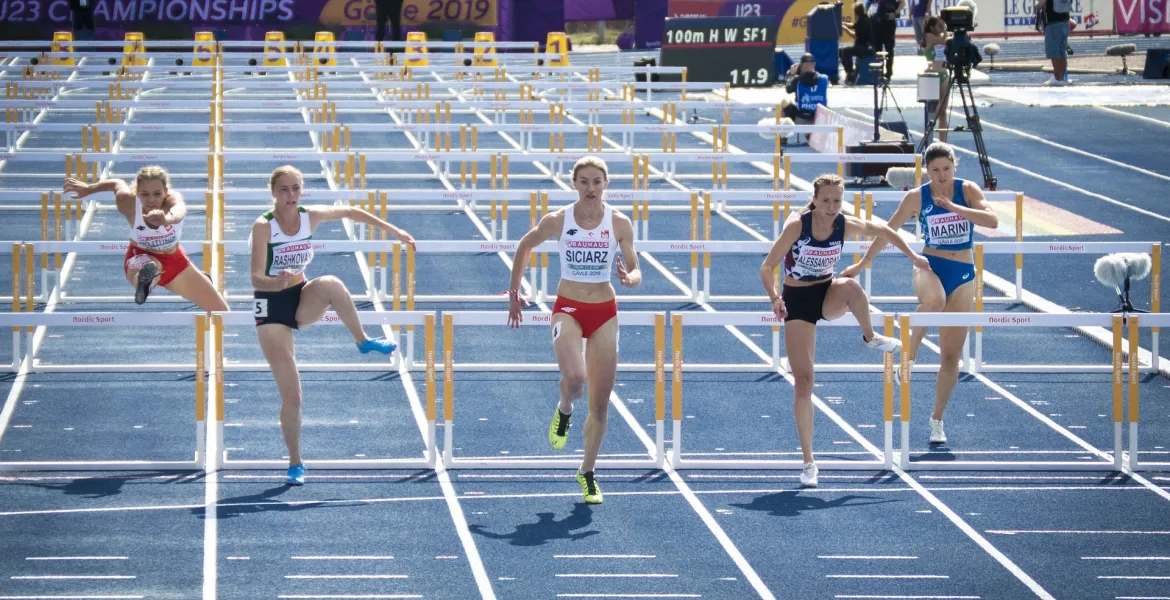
[899, 312, 1170, 471]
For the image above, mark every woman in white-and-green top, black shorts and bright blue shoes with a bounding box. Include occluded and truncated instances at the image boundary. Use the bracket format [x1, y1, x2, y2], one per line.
[248, 166, 414, 485]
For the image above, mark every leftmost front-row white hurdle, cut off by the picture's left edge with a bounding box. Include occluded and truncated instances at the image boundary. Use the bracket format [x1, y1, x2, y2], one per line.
[0, 312, 209, 471]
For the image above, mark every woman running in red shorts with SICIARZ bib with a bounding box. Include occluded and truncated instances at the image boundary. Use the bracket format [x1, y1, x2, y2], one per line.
[508, 157, 642, 504]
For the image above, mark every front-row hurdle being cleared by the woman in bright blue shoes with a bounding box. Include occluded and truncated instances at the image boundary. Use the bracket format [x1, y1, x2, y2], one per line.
[212, 311, 436, 470]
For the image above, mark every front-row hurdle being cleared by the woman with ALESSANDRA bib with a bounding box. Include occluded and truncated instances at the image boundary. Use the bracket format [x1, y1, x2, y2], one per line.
[669, 311, 894, 470]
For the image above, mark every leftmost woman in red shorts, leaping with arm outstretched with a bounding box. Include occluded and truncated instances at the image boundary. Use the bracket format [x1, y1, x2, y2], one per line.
[64, 166, 228, 311]
